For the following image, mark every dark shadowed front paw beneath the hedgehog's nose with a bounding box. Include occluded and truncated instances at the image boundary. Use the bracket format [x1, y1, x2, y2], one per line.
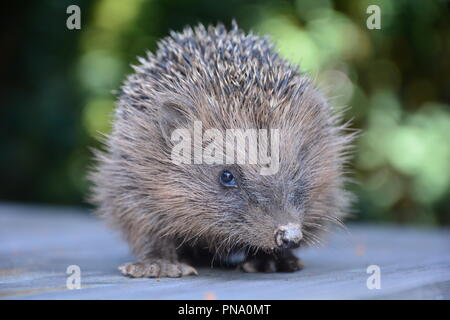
[240, 253, 304, 273]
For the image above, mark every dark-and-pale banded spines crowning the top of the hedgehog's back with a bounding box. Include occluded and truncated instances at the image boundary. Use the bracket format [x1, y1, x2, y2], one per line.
[129, 23, 298, 107]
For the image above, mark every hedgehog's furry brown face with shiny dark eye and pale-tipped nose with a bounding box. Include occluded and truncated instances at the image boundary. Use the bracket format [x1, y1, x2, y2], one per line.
[165, 149, 334, 250]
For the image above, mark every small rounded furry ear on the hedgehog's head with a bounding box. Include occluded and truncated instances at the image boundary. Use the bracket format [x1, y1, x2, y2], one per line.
[158, 101, 188, 144]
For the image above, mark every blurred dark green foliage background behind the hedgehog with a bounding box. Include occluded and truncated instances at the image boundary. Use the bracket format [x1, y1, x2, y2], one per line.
[0, 0, 450, 225]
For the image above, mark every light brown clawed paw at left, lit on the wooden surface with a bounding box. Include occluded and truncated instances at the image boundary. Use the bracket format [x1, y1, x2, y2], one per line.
[119, 259, 198, 278]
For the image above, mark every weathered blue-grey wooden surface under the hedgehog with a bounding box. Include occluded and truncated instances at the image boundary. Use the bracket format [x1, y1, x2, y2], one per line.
[0, 204, 450, 299]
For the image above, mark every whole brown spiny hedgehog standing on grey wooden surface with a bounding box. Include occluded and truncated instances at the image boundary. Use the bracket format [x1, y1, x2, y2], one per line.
[89, 22, 355, 278]
